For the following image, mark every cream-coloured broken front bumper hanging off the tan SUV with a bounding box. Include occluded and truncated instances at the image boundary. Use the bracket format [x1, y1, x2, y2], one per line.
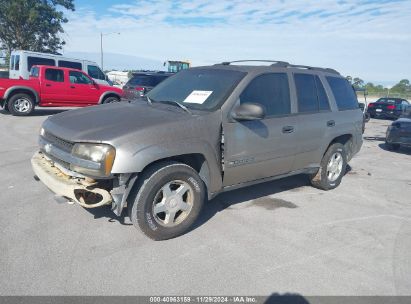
[31, 152, 113, 208]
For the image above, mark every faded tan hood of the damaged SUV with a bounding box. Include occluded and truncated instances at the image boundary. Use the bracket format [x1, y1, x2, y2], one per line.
[43, 102, 198, 143]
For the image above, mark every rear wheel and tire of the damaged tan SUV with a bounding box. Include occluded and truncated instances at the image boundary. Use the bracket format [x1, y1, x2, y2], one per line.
[310, 143, 347, 190]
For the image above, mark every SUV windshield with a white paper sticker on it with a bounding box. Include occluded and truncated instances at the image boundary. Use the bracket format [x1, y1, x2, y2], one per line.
[147, 69, 246, 111]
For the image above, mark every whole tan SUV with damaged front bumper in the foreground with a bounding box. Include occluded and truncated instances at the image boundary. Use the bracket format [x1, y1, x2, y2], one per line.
[32, 62, 363, 240]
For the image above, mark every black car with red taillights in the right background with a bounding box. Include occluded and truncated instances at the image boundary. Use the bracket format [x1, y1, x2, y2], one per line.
[367, 97, 410, 119]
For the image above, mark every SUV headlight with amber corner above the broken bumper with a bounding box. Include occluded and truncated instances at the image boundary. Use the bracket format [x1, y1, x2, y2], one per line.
[70, 144, 116, 177]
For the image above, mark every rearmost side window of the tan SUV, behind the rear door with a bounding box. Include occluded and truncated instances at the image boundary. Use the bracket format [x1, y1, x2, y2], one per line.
[326, 76, 359, 110]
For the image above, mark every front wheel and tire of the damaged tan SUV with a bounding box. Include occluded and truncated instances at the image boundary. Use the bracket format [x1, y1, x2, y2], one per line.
[127, 162, 206, 241]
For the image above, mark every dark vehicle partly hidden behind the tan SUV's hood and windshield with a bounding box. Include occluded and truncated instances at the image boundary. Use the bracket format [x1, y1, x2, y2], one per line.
[123, 72, 174, 100]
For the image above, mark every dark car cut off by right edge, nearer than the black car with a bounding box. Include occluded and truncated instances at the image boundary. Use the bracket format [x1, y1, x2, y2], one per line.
[385, 109, 411, 150]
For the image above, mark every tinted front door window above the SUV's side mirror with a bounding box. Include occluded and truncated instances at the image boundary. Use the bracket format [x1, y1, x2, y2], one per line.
[240, 73, 291, 116]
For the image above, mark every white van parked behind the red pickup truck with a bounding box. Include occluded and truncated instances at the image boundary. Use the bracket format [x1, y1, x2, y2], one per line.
[9, 50, 110, 85]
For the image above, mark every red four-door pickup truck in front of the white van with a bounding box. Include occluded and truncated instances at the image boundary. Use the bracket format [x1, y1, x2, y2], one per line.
[0, 65, 123, 116]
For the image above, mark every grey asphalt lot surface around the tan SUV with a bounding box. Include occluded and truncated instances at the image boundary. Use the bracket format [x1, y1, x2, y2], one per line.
[0, 110, 411, 296]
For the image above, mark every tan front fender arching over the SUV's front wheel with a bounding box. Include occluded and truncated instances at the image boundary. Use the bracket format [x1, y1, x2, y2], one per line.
[112, 139, 222, 193]
